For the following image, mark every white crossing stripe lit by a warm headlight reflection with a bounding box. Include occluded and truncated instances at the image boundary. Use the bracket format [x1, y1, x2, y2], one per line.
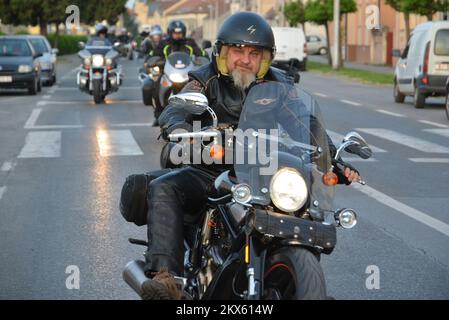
[97, 130, 143, 157]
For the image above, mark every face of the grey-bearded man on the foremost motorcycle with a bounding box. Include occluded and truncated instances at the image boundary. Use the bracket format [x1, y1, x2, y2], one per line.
[226, 46, 263, 75]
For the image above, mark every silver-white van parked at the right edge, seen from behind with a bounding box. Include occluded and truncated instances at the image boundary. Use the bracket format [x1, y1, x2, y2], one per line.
[393, 21, 449, 108]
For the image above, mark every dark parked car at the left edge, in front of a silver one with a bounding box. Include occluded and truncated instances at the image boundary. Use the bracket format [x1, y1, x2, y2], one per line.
[0, 36, 42, 95]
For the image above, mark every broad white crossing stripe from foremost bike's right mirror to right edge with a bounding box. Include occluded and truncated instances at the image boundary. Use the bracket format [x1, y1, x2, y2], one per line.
[356, 128, 449, 153]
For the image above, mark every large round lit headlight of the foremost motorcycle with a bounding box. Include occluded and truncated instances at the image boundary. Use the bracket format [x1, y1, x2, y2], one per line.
[270, 168, 309, 213]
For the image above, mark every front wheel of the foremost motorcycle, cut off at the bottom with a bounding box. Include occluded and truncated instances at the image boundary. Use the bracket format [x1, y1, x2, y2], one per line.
[263, 247, 327, 300]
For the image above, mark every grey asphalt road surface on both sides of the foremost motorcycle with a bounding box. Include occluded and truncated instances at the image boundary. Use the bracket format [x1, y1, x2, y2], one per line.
[0, 56, 449, 299]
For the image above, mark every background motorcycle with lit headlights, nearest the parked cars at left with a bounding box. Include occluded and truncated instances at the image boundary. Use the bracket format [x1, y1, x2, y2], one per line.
[76, 39, 122, 104]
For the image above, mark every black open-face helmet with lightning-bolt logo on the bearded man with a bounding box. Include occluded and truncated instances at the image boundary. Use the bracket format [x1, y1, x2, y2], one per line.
[214, 12, 276, 78]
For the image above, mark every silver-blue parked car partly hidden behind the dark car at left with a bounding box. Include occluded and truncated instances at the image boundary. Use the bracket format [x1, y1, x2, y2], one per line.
[27, 36, 59, 86]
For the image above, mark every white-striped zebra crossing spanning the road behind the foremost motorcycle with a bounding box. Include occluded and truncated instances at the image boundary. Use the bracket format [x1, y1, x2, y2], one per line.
[9, 124, 449, 163]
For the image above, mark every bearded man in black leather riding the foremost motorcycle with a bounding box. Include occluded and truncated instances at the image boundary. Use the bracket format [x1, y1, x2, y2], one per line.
[121, 12, 359, 299]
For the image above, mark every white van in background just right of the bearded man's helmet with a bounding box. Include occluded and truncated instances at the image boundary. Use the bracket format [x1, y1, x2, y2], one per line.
[272, 27, 307, 71]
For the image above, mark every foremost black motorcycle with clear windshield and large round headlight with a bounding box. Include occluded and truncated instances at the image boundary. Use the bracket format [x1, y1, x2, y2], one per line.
[123, 82, 372, 300]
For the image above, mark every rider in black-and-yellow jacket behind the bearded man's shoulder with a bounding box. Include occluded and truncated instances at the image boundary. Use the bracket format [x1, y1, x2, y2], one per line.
[148, 20, 208, 126]
